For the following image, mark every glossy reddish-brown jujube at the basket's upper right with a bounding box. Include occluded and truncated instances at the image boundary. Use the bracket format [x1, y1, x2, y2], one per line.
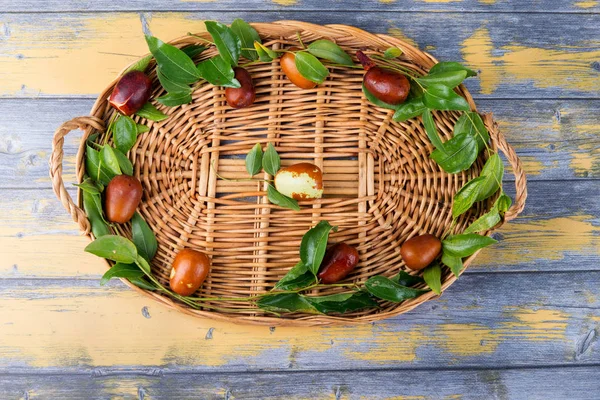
[363, 67, 410, 105]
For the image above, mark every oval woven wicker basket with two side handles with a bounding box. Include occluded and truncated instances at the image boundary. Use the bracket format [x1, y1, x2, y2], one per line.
[50, 21, 527, 326]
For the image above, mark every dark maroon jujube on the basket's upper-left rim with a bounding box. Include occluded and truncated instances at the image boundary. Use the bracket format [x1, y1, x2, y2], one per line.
[109, 71, 152, 115]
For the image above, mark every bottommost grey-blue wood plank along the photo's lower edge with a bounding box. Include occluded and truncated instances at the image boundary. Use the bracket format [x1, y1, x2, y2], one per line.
[0, 367, 600, 400]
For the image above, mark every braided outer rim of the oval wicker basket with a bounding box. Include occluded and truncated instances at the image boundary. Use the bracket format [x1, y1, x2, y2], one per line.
[51, 20, 526, 326]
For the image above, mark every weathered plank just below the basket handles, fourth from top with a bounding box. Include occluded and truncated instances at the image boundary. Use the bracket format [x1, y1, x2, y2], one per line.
[0, 180, 600, 279]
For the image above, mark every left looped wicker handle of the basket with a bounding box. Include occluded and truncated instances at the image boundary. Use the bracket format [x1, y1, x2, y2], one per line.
[50, 117, 104, 234]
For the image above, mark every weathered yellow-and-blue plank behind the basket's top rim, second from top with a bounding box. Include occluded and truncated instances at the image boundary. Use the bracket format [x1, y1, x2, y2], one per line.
[0, 12, 600, 98]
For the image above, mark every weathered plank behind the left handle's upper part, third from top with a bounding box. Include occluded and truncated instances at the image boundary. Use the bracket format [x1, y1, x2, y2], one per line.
[0, 99, 600, 188]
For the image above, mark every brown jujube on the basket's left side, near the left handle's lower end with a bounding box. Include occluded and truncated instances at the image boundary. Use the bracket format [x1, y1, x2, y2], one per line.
[104, 175, 142, 224]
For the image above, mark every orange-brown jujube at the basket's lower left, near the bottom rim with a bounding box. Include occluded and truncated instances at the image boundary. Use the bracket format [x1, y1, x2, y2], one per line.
[169, 249, 210, 296]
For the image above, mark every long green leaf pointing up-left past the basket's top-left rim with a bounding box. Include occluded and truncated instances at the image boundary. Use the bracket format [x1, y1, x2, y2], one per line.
[146, 36, 200, 84]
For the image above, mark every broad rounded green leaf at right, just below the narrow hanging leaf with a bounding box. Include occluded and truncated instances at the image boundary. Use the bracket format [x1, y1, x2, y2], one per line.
[431, 135, 478, 174]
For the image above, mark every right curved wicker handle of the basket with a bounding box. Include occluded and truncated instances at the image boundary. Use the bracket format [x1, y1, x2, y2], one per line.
[483, 113, 527, 221]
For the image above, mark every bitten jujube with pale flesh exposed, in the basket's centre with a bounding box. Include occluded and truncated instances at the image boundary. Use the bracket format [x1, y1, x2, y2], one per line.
[275, 163, 323, 200]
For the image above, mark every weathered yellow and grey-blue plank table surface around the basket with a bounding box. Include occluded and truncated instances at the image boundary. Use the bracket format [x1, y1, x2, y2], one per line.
[0, 0, 600, 399]
